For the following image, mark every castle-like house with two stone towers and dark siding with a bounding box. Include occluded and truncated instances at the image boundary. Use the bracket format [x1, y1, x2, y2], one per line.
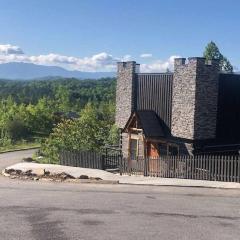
[116, 57, 240, 158]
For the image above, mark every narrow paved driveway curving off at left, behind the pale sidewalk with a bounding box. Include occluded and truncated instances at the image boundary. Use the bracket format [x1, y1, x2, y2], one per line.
[0, 149, 36, 171]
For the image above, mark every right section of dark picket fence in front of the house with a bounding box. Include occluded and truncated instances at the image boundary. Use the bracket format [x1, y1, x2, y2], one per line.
[120, 155, 240, 182]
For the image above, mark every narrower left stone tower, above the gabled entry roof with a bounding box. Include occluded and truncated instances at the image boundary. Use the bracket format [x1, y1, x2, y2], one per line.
[116, 62, 138, 128]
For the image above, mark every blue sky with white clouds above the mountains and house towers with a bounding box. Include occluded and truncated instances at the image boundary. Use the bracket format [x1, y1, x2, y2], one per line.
[0, 0, 240, 71]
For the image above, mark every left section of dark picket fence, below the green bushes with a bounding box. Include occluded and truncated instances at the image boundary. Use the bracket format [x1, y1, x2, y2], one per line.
[59, 148, 122, 170]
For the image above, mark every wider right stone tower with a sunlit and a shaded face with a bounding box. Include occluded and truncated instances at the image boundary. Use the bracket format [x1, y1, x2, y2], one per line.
[171, 58, 219, 140]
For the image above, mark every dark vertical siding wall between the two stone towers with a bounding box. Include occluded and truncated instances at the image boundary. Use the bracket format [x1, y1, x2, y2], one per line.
[136, 73, 173, 129]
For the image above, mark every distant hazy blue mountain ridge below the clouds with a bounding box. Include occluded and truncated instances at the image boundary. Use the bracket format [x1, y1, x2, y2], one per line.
[0, 62, 116, 80]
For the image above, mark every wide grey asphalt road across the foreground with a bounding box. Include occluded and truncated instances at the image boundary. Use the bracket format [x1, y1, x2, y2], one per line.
[0, 149, 240, 240]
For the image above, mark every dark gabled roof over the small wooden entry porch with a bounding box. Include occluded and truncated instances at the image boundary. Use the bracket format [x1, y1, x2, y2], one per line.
[123, 110, 166, 138]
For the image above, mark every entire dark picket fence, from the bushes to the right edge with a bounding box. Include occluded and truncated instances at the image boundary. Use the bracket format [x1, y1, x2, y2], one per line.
[60, 151, 240, 182]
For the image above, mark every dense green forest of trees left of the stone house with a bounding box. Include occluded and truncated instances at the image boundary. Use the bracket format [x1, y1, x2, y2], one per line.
[0, 78, 117, 160]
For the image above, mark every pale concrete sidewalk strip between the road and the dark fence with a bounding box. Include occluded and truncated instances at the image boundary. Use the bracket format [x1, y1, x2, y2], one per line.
[2, 162, 240, 190]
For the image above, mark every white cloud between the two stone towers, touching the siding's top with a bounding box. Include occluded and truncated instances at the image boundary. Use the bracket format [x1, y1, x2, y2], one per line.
[140, 56, 180, 73]
